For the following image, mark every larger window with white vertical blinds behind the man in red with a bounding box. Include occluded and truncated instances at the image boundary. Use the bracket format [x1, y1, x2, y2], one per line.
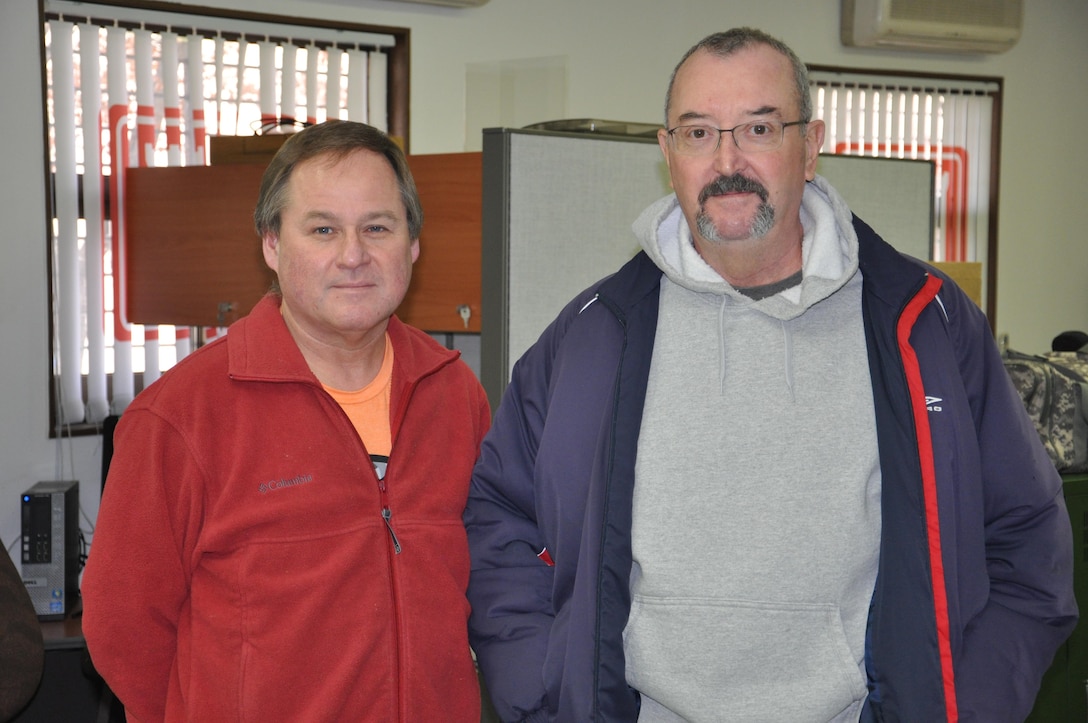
[42, 0, 408, 434]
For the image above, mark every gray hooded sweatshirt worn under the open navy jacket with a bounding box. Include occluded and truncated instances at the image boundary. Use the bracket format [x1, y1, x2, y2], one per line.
[623, 176, 880, 723]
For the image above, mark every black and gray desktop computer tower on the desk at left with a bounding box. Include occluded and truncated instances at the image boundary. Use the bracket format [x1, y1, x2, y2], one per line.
[21, 481, 79, 620]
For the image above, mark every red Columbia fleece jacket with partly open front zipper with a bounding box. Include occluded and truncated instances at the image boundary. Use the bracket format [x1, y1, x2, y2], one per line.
[83, 296, 490, 722]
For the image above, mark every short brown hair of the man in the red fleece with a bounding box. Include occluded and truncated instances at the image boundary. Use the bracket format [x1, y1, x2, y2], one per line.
[254, 120, 423, 240]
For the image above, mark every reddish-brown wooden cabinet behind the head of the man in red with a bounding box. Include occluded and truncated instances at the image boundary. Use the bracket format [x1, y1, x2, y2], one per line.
[123, 146, 482, 333]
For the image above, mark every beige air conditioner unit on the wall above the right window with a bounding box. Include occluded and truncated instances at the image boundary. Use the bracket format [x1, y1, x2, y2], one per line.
[840, 0, 1024, 53]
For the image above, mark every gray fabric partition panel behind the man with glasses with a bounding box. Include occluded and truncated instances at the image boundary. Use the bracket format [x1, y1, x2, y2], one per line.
[480, 128, 934, 409]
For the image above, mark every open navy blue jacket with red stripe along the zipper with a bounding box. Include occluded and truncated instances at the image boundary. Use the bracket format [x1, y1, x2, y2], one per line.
[465, 217, 1077, 723]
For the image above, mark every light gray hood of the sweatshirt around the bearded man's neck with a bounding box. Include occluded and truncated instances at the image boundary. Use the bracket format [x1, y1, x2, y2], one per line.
[632, 175, 857, 321]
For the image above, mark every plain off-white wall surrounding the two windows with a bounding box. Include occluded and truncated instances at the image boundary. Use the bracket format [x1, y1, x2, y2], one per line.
[0, 0, 1088, 546]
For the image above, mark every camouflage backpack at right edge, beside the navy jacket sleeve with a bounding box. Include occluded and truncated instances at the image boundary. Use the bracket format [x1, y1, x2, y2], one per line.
[1003, 350, 1088, 474]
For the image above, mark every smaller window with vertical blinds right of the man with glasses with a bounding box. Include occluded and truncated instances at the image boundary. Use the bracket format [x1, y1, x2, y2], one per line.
[809, 65, 1002, 325]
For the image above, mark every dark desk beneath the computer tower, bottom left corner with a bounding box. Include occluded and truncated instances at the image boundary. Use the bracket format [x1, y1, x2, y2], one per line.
[12, 608, 125, 723]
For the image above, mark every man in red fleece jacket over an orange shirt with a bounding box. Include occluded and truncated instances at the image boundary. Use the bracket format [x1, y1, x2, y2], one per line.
[83, 121, 490, 723]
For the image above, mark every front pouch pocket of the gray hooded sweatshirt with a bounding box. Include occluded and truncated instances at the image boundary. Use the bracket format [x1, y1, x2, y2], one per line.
[623, 595, 866, 723]
